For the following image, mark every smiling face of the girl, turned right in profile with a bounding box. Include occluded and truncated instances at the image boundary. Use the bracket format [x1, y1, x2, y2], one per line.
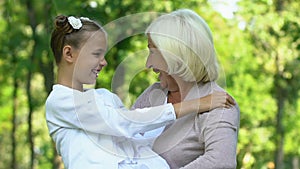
[73, 31, 107, 86]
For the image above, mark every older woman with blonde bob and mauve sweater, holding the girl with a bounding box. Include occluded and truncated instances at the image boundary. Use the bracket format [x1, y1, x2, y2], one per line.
[133, 9, 240, 169]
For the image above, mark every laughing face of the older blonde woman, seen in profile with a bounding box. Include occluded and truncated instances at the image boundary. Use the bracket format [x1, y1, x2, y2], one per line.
[146, 35, 179, 92]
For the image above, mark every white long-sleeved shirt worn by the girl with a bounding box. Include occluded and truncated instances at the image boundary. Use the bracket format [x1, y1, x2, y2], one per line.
[46, 85, 176, 169]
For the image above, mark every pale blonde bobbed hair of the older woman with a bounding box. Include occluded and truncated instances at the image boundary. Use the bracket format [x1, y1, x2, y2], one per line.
[146, 9, 218, 82]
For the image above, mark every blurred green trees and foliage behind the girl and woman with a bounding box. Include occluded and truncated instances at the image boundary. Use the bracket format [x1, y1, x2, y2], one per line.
[0, 0, 300, 169]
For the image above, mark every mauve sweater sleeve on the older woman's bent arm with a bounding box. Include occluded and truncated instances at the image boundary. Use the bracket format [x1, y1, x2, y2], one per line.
[181, 107, 239, 169]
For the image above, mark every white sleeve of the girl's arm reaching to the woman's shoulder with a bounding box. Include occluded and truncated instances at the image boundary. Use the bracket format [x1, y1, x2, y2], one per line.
[46, 90, 176, 137]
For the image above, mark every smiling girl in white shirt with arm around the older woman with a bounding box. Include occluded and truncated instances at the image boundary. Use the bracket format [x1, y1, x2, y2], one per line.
[46, 16, 233, 169]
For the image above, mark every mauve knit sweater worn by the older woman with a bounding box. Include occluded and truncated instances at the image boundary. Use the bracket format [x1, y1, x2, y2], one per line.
[133, 82, 240, 169]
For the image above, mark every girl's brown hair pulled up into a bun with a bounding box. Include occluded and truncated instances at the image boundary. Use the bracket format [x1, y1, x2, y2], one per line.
[51, 15, 105, 64]
